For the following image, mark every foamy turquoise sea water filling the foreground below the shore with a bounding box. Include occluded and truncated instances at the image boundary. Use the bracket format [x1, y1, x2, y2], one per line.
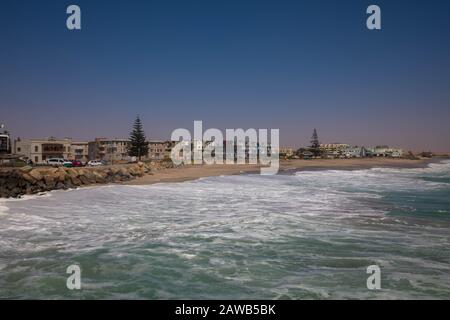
[0, 161, 450, 299]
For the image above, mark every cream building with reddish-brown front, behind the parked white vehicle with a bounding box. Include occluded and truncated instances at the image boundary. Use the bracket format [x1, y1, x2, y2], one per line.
[14, 137, 72, 164]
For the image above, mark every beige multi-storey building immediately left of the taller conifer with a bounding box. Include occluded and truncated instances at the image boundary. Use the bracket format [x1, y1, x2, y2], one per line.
[88, 138, 131, 163]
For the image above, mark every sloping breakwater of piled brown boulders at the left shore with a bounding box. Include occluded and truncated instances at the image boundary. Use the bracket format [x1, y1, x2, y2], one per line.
[0, 163, 152, 198]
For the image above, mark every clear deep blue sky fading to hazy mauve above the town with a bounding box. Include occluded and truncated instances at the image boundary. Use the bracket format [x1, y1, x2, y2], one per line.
[0, 0, 450, 151]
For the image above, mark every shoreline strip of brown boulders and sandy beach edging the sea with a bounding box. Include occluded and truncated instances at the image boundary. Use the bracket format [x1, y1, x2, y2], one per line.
[0, 157, 450, 198]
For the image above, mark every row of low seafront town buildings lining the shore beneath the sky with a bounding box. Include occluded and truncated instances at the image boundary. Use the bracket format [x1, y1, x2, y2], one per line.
[0, 121, 433, 165]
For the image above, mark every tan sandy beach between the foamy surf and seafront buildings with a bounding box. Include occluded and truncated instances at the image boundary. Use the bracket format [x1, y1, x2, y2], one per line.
[125, 158, 438, 185]
